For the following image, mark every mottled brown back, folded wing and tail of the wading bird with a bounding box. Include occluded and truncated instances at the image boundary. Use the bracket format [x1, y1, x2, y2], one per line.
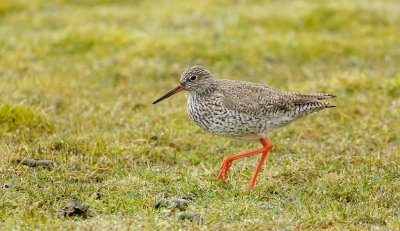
[217, 80, 335, 117]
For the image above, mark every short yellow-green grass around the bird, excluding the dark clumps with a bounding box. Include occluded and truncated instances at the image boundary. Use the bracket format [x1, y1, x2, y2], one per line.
[0, 0, 400, 230]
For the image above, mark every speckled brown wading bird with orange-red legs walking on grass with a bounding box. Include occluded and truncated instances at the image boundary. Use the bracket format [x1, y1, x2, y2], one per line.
[153, 65, 335, 189]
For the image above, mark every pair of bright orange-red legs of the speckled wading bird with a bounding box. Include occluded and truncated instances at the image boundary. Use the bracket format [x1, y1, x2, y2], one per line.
[217, 137, 272, 189]
